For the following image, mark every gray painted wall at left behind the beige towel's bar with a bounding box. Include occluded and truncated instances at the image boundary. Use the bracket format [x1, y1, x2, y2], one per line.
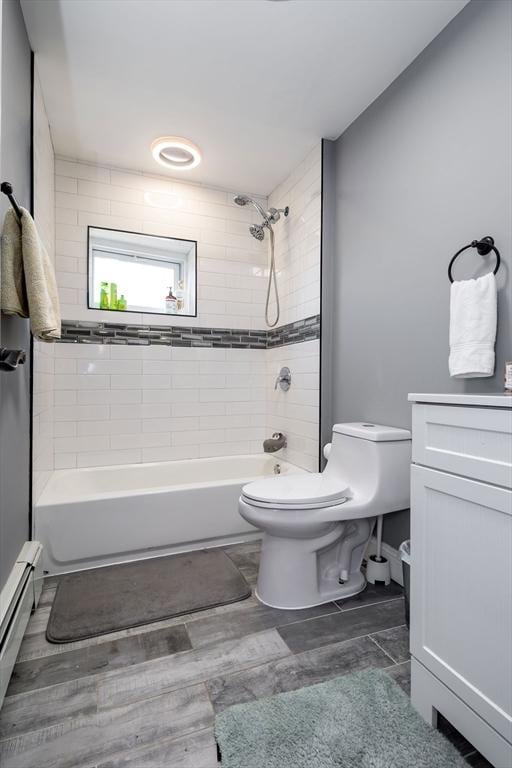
[0, 0, 31, 589]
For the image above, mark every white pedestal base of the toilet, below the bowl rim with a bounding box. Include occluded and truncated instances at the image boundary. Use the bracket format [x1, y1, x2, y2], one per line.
[256, 518, 375, 610]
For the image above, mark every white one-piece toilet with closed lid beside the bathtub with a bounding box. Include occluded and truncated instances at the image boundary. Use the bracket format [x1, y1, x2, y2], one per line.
[239, 423, 411, 609]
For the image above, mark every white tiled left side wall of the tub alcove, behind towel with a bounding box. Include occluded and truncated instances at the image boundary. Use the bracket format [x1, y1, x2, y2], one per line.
[32, 69, 55, 501]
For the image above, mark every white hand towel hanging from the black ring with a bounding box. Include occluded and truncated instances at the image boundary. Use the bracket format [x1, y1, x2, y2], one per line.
[448, 272, 497, 379]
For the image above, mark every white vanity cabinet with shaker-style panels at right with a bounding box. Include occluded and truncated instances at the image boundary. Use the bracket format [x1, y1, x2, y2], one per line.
[409, 394, 512, 768]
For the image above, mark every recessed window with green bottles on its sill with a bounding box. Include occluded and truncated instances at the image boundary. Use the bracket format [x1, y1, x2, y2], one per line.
[88, 227, 197, 317]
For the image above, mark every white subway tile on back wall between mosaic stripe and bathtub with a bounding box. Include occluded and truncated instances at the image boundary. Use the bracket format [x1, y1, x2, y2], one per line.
[50, 344, 267, 469]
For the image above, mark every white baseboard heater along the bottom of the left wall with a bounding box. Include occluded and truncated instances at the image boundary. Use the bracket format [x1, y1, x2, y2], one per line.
[0, 541, 43, 707]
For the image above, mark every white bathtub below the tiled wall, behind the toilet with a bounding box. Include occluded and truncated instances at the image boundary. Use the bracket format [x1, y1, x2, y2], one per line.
[38, 454, 305, 574]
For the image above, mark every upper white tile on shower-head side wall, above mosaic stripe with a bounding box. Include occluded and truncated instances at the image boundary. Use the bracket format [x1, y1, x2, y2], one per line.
[269, 144, 322, 325]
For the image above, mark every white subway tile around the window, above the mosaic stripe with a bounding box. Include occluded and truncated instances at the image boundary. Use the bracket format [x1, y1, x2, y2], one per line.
[55, 158, 267, 329]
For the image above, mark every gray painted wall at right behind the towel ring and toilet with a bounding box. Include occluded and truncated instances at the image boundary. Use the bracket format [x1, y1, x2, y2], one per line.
[332, 0, 512, 546]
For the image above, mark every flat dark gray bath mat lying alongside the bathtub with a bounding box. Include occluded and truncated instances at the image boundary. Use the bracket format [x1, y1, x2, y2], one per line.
[46, 549, 251, 643]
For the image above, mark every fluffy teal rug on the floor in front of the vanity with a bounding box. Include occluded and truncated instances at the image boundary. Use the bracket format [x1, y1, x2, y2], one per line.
[215, 670, 467, 768]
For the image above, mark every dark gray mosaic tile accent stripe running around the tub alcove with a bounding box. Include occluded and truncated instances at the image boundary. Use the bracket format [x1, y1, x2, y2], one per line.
[60, 315, 320, 349]
